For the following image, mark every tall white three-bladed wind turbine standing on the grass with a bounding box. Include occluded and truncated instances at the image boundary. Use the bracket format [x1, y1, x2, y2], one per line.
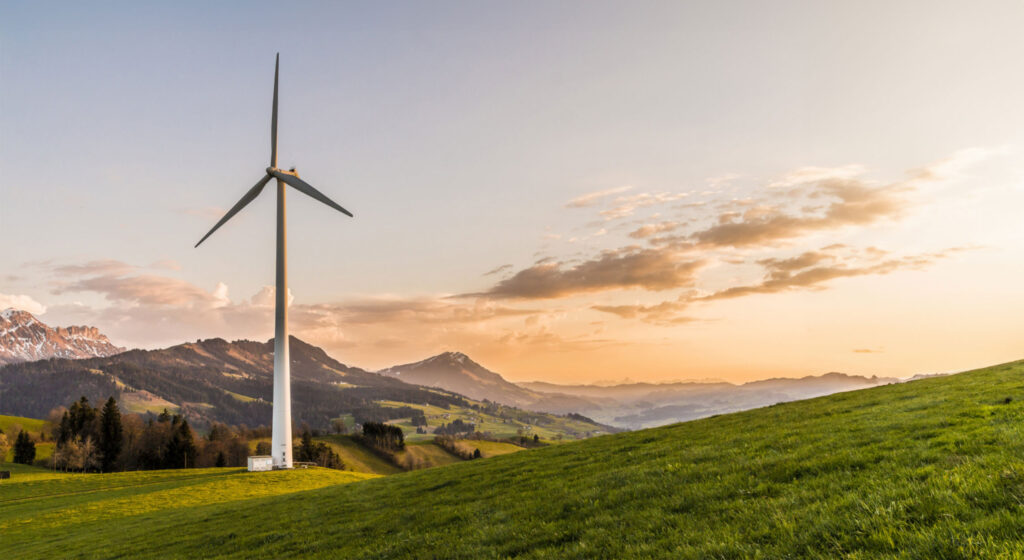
[196, 52, 352, 469]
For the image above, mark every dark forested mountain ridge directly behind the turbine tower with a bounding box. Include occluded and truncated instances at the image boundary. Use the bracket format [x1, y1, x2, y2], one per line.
[0, 337, 609, 438]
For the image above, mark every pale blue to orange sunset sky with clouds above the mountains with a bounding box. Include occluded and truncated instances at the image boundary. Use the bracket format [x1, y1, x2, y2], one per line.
[0, 1, 1024, 383]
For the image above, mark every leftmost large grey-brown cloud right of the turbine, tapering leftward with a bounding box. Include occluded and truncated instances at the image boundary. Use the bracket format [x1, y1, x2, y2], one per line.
[463, 248, 705, 299]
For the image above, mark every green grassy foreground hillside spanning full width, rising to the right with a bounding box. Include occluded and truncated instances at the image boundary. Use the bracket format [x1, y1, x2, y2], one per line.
[0, 362, 1024, 558]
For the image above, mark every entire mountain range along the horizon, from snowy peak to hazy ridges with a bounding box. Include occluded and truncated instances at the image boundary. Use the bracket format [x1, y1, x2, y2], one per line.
[0, 309, 913, 429]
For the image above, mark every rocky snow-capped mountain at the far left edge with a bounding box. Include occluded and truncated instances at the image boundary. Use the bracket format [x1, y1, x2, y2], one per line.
[0, 308, 125, 364]
